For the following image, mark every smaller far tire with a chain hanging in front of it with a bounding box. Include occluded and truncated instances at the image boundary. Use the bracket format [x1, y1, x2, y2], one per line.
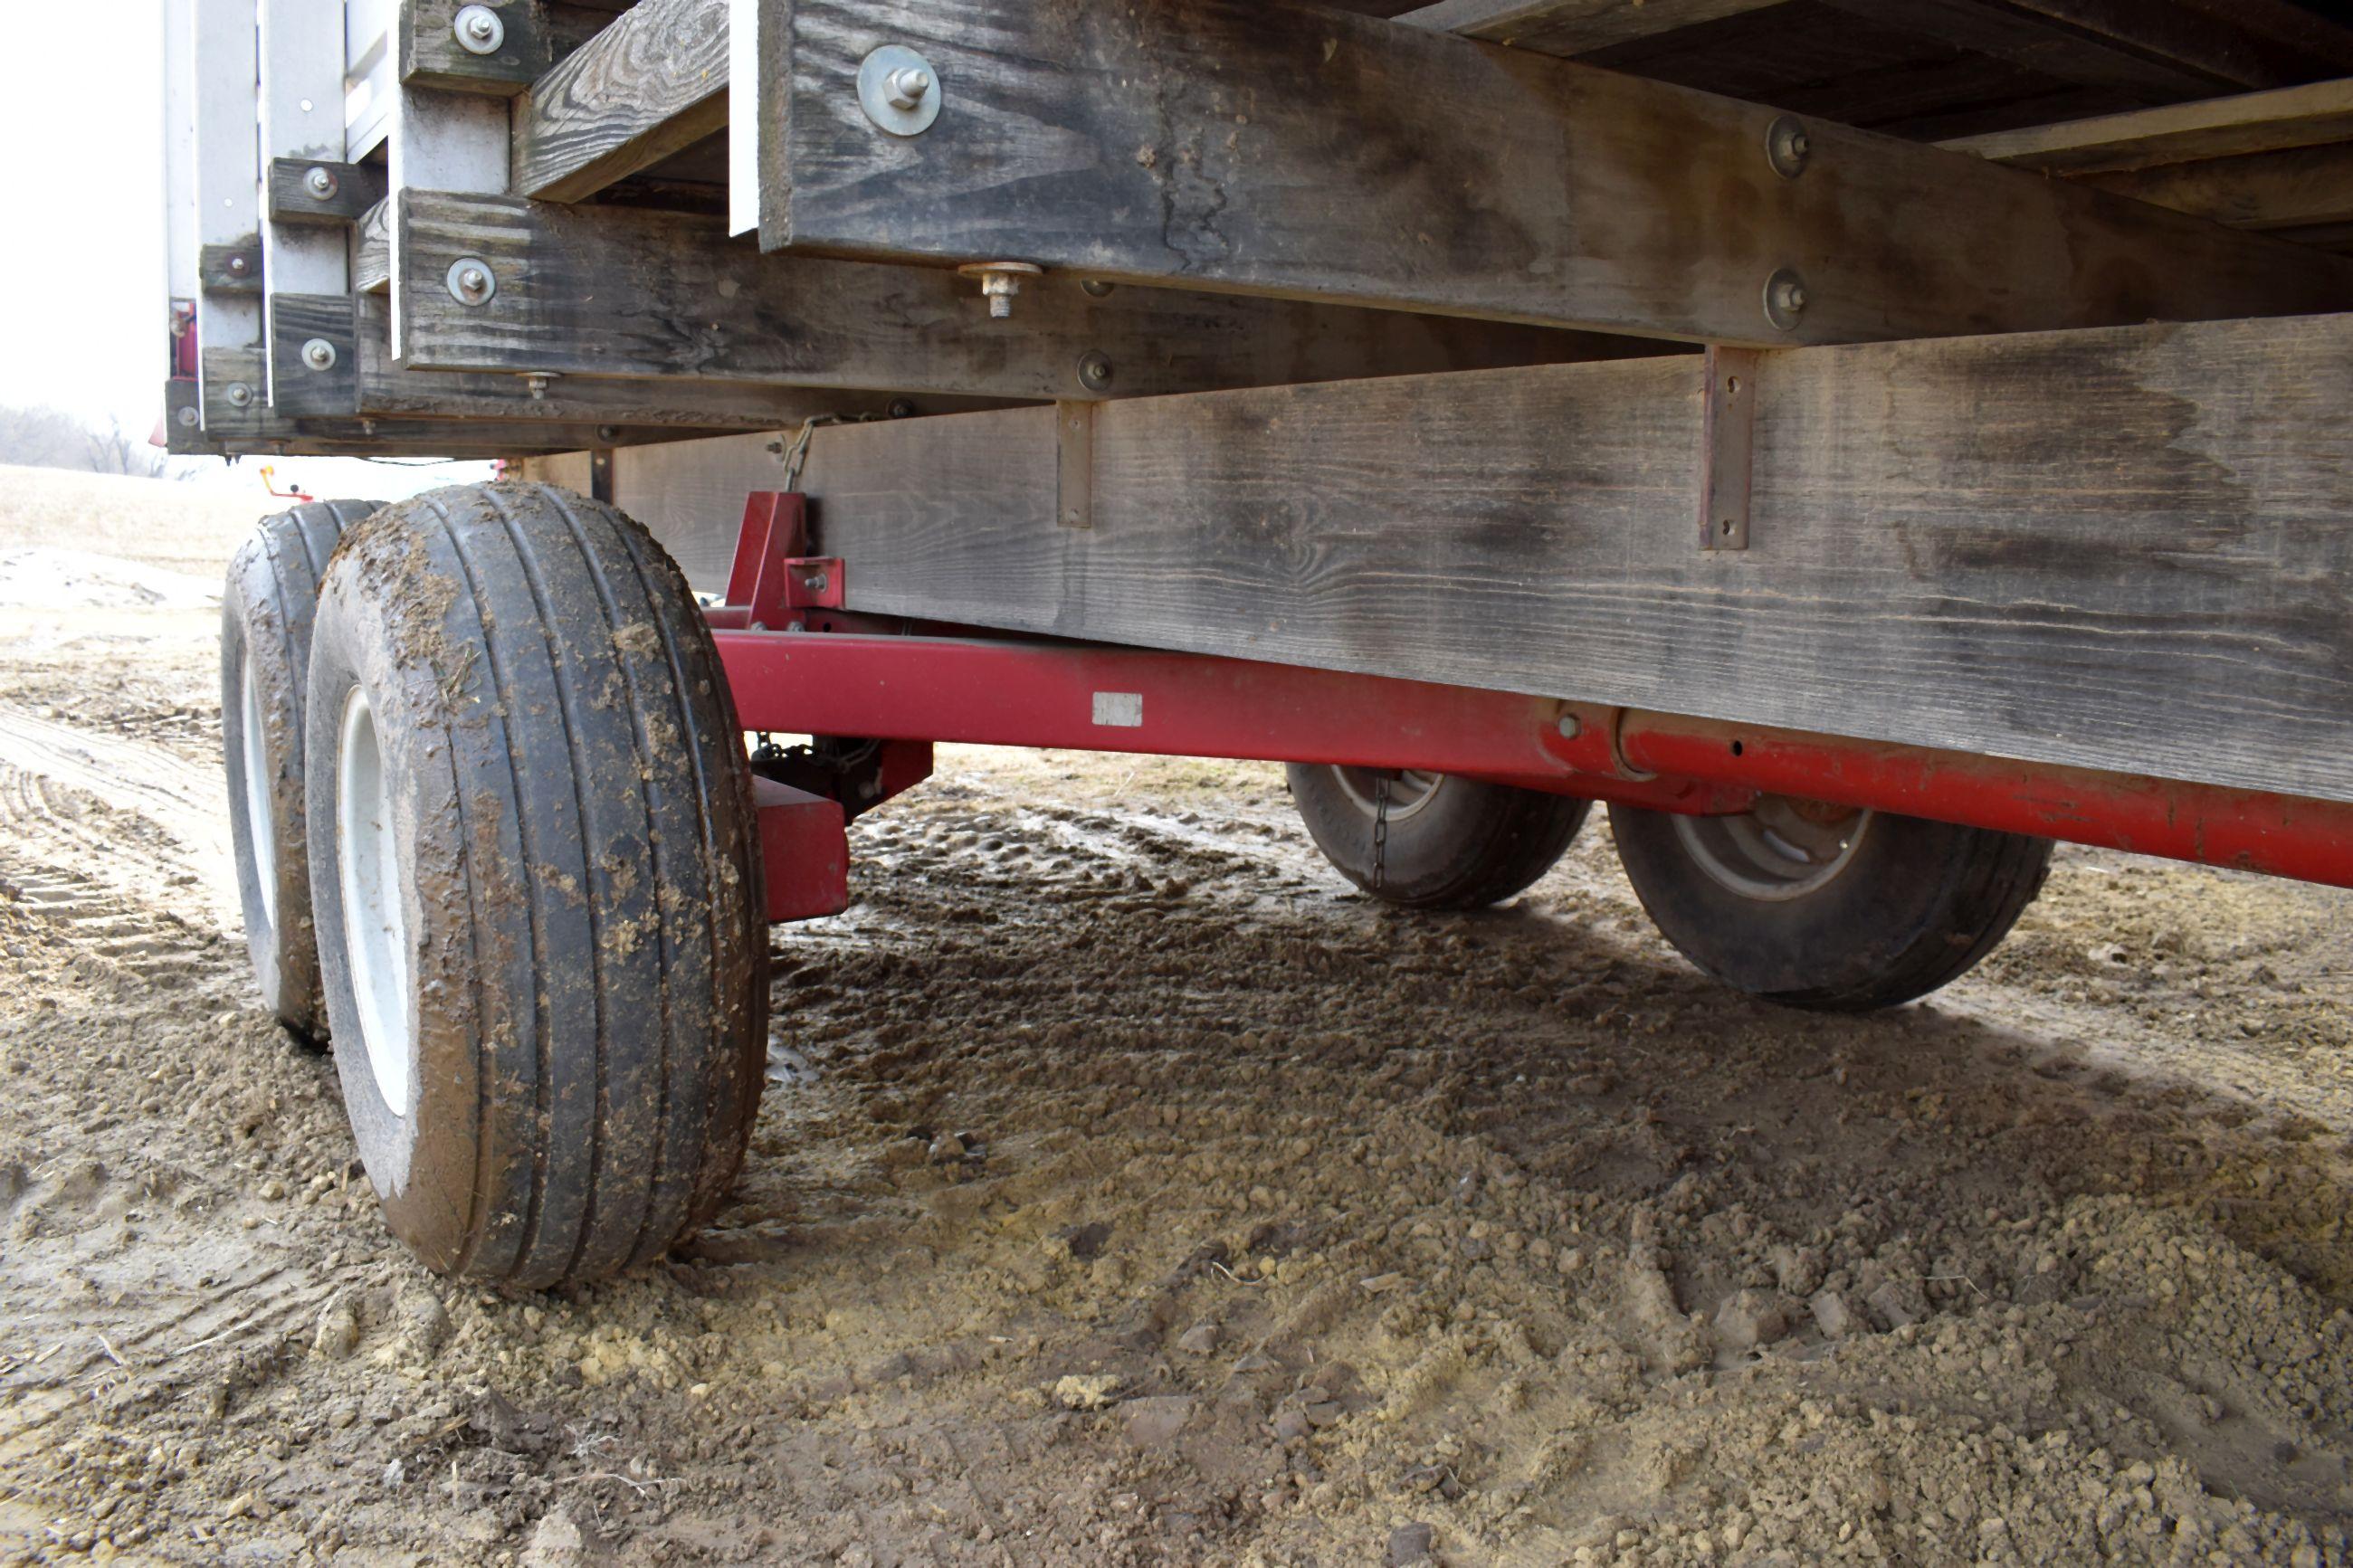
[1290, 764, 1593, 910]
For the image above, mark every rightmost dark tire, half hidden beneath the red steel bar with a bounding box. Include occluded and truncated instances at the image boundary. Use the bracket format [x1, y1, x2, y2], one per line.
[1609, 799, 2052, 1013]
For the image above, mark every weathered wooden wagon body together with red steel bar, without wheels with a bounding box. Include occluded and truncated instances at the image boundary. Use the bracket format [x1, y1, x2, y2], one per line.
[167, 0, 2353, 908]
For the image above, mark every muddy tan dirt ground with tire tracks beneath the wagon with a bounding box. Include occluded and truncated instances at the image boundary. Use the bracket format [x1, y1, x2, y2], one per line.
[0, 475, 2353, 1568]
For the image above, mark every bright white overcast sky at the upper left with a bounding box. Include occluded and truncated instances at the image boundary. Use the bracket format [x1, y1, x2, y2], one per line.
[0, 0, 169, 435]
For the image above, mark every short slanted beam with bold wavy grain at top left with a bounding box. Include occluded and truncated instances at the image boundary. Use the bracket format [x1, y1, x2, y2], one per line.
[513, 0, 729, 202]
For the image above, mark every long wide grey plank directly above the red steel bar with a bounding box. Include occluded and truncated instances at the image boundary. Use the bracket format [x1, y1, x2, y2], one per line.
[807, 318, 2353, 802]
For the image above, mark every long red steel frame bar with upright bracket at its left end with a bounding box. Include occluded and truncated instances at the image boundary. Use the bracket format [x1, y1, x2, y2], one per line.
[710, 496, 2353, 902]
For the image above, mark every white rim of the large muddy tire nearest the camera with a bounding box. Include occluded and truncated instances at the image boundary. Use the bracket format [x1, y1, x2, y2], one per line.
[334, 687, 414, 1117]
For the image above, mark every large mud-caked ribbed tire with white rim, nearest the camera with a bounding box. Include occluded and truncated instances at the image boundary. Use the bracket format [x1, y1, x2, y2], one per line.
[310, 484, 767, 1288]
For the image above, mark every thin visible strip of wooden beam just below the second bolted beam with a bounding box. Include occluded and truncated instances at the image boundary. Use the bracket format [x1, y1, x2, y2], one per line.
[348, 294, 1003, 430]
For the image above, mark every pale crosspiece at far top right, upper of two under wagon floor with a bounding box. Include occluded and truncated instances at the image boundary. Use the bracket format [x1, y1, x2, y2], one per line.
[1944, 80, 2353, 174]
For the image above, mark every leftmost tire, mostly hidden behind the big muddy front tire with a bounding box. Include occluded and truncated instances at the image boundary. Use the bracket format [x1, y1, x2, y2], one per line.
[221, 500, 381, 1044]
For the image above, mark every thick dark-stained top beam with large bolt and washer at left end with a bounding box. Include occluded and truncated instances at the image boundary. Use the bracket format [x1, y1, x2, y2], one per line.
[757, 0, 2353, 346]
